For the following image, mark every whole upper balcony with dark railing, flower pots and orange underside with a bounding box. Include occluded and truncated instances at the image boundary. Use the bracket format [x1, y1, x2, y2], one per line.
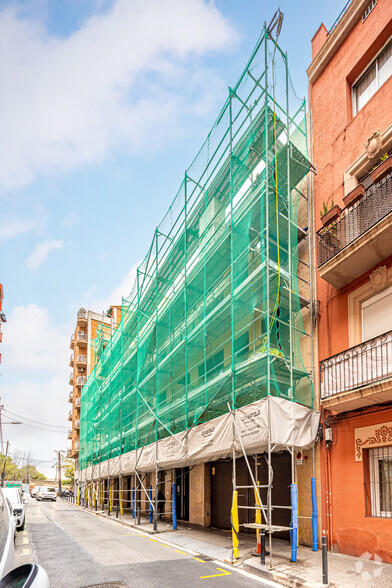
[317, 174, 392, 288]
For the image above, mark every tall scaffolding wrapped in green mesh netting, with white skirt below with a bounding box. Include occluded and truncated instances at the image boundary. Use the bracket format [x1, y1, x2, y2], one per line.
[79, 26, 317, 560]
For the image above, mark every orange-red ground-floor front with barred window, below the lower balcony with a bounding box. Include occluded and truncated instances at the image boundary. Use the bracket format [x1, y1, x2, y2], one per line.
[321, 406, 392, 563]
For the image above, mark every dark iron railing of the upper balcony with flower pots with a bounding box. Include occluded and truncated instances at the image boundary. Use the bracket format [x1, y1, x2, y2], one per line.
[317, 174, 392, 267]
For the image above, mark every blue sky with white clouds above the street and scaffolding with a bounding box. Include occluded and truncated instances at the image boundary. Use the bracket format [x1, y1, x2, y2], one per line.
[0, 0, 346, 477]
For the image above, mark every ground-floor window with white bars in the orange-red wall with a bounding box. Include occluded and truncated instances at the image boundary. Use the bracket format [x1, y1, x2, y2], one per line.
[365, 447, 392, 518]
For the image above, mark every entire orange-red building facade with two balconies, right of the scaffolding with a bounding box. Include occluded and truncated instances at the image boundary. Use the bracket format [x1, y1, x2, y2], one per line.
[307, 0, 392, 563]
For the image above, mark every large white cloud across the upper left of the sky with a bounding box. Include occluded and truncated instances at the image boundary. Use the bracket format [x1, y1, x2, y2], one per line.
[0, 0, 236, 188]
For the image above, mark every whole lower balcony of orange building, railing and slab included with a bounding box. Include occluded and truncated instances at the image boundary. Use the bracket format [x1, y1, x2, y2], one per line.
[320, 331, 392, 412]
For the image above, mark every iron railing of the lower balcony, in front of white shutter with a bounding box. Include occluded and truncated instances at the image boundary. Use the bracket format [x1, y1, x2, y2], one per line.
[320, 331, 392, 400]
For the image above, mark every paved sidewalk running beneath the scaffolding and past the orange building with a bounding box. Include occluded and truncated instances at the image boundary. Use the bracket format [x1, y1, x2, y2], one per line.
[63, 500, 392, 588]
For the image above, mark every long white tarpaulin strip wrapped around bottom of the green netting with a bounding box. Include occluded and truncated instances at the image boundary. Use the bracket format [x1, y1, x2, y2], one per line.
[79, 396, 320, 481]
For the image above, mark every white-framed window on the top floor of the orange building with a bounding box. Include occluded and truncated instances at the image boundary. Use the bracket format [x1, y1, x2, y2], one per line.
[353, 41, 392, 115]
